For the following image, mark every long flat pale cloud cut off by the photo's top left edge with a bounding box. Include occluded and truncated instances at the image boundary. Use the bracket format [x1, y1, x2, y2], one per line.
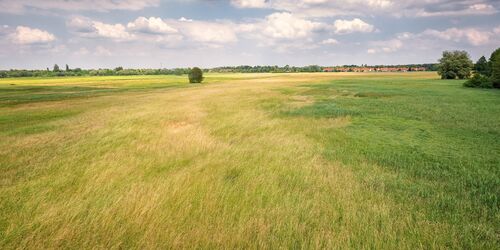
[0, 0, 160, 13]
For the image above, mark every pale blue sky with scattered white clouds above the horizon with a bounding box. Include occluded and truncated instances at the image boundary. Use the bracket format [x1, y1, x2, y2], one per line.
[0, 0, 500, 69]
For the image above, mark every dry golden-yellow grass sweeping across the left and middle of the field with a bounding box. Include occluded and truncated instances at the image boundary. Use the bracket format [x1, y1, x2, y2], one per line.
[0, 73, 498, 249]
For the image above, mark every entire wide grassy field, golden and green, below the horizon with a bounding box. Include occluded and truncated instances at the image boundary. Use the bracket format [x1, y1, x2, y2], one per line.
[0, 72, 500, 249]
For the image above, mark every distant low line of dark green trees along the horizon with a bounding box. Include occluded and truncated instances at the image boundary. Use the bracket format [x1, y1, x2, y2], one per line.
[0, 64, 437, 78]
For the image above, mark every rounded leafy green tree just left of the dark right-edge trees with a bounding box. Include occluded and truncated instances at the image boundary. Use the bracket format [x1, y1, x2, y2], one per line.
[438, 50, 474, 79]
